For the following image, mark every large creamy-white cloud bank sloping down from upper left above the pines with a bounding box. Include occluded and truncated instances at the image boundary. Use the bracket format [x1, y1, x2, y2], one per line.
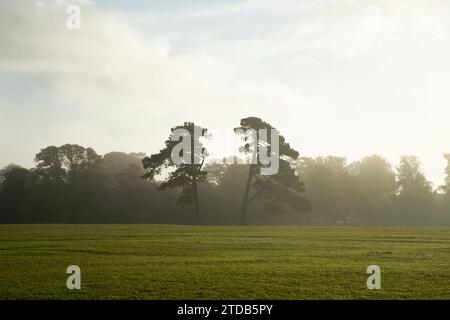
[0, 1, 306, 164]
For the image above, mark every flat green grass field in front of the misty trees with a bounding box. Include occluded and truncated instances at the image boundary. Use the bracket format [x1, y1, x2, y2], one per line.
[0, 225, 450, 299]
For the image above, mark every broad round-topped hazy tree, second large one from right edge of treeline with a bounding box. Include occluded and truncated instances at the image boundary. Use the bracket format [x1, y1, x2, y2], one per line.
[349, 155, 396, 225]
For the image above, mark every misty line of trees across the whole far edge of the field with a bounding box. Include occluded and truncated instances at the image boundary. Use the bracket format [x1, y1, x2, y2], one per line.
[0, 117, 450, 226]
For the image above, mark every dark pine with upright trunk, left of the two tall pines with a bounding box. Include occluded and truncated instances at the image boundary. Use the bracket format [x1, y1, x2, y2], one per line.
[142, 122, 207, 224]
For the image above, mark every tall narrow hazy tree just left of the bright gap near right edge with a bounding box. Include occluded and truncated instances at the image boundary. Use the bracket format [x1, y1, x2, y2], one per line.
[396, 156, 435, 226]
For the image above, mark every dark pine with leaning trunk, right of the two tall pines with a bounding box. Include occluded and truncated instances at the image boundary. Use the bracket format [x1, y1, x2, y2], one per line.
[236, 117, 311, 225]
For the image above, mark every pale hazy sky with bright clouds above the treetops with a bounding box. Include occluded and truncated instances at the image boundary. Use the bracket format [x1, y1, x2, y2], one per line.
[0, 0, 450, 186]
